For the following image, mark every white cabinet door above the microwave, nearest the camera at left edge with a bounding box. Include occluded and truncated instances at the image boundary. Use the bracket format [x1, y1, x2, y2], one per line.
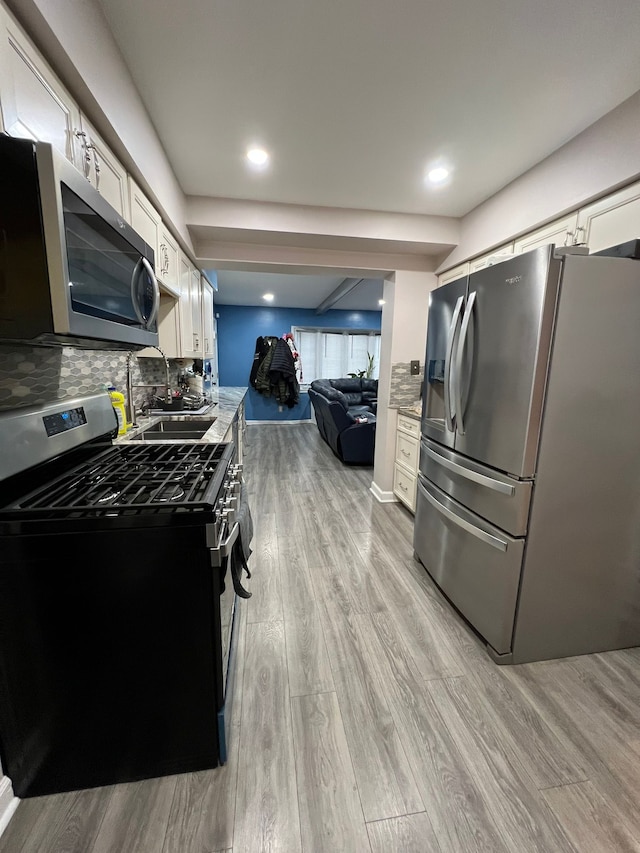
[0, 7, 83, 169]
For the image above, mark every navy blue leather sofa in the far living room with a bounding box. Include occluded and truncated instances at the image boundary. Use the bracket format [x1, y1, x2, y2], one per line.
[309, 379, 378, 465]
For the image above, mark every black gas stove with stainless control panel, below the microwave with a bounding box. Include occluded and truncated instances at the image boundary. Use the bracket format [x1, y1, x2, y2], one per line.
[0, 393, 248, 797]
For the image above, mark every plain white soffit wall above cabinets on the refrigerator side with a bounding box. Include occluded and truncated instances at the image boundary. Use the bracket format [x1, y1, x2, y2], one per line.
[439, 92, 640, 270]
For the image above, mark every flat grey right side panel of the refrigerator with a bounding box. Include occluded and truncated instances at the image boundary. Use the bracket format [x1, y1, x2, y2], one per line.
[513, 257, 640, 663]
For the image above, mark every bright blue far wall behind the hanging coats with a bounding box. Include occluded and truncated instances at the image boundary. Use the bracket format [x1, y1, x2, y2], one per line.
[215, 305, 382, 421]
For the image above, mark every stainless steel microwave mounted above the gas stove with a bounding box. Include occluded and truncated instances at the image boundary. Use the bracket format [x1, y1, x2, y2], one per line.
[0, 134, 160, 349]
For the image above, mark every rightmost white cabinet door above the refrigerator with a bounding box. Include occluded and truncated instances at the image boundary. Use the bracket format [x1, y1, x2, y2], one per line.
[577, 183, 640, 252]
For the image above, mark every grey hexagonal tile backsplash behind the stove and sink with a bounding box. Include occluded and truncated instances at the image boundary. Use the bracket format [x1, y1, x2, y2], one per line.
[0, 344, 175, 410]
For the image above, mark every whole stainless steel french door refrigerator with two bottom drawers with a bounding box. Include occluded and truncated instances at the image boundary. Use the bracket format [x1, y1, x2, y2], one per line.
[414, 245, 640, 663]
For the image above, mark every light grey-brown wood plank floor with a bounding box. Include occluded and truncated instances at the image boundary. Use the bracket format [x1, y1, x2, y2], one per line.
[0, 425, 640, 853]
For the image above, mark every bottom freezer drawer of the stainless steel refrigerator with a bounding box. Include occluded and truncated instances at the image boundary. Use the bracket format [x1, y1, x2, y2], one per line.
[413, 477, 524, 654]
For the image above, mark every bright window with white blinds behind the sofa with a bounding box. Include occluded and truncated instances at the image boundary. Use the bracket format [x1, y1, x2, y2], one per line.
[291, 327, 380, 385]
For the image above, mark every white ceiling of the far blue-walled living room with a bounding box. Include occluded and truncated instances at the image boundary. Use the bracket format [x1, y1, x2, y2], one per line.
[210, 270, 383, 311]
